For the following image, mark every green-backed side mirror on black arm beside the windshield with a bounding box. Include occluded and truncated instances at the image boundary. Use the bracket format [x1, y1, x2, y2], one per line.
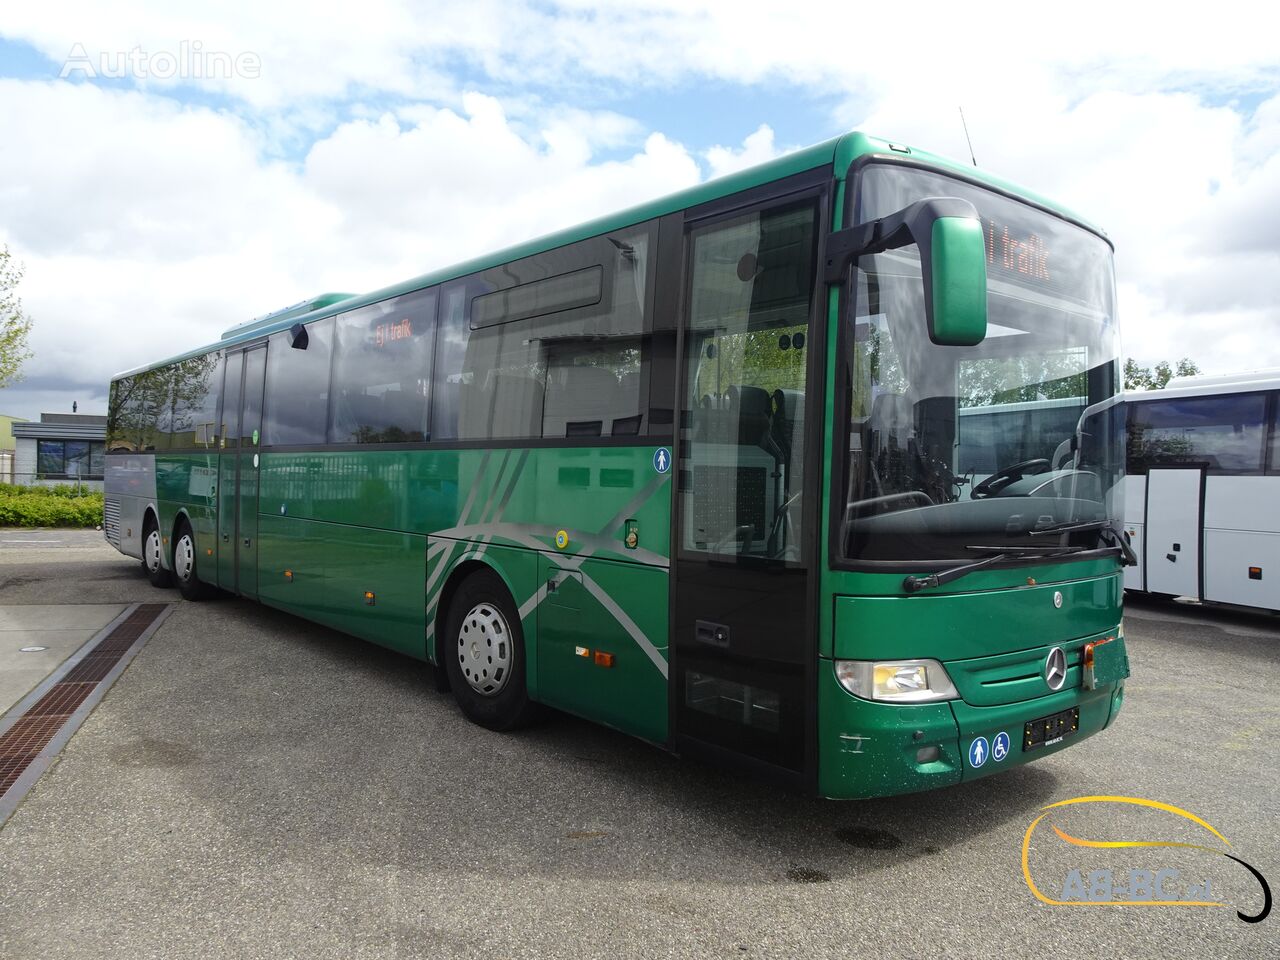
[826, 197, 987, 347]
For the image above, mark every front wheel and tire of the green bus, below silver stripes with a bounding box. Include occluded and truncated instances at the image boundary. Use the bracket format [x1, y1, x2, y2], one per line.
[440, 571, 538, 731]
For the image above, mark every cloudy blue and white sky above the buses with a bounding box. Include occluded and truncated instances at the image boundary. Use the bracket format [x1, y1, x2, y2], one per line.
[0, 0, 1280, 419]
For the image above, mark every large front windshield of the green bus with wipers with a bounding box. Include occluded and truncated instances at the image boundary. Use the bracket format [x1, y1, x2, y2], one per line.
[837, 164, 1124, 562]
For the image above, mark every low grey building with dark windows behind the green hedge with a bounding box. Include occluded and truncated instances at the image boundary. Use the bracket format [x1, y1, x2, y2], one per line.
[12, 413, 106, 490]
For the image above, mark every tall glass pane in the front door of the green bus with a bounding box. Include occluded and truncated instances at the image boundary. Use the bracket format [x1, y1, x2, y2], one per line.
[680, 202, 817, 566]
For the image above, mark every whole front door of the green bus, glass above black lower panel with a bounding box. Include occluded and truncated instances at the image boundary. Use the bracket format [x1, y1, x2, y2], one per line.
[671, 193, 824, 778]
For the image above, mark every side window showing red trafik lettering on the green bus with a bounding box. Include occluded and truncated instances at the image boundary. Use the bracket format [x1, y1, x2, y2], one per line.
[329, 291, 435, 443]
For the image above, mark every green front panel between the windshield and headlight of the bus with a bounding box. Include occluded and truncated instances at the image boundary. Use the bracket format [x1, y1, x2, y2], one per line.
[835, 573, 1120, 662]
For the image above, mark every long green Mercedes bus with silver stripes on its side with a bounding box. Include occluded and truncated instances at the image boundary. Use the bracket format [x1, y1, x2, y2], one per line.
[104, 133, 1128, 797]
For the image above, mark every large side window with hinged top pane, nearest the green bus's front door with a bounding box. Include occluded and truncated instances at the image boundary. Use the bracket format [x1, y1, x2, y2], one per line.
[434, 225, 655, 439]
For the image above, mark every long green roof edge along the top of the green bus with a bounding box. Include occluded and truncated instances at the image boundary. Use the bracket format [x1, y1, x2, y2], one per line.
[113, 132, 1110, 379]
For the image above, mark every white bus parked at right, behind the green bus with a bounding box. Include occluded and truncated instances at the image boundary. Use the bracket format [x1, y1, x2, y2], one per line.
[1124, 370, 1280, 611]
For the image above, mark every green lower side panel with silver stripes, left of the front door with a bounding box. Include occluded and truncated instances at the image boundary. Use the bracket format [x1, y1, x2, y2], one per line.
[170, 445, 671, 742]
